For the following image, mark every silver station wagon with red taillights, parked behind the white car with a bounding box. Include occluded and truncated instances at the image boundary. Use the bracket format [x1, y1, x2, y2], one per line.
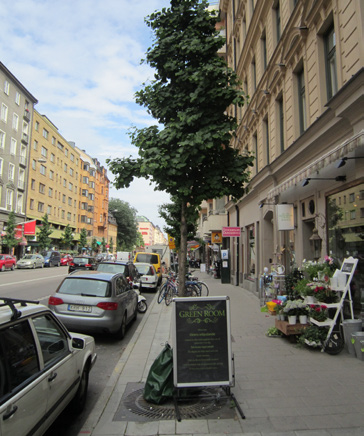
[48, 271, 138, 339]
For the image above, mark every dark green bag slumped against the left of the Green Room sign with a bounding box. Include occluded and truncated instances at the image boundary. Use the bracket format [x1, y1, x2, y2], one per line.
[143, 344, 173, 404]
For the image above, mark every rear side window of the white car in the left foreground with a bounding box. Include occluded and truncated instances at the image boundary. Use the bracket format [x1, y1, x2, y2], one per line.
[0, 321, 39, 395]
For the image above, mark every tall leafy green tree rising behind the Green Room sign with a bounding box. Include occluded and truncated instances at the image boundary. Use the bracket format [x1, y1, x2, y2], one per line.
[107, 0, 254, 295]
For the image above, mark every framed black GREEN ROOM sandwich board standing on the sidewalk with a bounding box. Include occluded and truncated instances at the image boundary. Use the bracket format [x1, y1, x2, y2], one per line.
[173, 296, 233, 387]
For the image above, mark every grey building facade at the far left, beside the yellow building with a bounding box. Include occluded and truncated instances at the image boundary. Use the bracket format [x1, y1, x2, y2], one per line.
[0, 62, 38, 257]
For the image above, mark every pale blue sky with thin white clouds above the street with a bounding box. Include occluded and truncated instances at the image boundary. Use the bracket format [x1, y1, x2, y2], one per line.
[0, 0, 193, 235]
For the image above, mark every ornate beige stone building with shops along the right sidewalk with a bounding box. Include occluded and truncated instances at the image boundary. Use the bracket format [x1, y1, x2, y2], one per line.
[208, 0, 364, 314]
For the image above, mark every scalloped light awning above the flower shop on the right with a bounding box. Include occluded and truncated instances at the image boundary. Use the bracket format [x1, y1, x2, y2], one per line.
[267, 130, 364, 200]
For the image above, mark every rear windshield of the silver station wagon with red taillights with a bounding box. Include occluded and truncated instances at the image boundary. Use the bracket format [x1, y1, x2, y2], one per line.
[58, 278, 111, 297]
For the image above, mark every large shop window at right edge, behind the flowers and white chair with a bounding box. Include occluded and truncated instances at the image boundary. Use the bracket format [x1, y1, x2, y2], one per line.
[327, 183, 364, 316]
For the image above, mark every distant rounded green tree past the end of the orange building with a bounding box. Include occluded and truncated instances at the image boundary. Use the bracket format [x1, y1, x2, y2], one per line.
[109, 198, 137, 251]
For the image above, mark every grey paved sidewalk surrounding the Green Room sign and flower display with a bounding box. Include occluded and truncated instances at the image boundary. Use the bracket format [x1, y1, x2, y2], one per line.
[79, 273, 364, 436]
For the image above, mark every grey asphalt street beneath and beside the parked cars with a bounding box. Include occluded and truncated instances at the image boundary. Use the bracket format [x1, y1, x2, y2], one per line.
[0, 267, 154, 436]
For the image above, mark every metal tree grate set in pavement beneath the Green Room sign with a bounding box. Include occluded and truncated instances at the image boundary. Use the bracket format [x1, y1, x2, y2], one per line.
[113, 383, 235, 421]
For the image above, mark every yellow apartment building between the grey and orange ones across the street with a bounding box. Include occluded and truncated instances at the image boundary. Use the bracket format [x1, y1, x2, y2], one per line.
[26, 110, 80, 248]
